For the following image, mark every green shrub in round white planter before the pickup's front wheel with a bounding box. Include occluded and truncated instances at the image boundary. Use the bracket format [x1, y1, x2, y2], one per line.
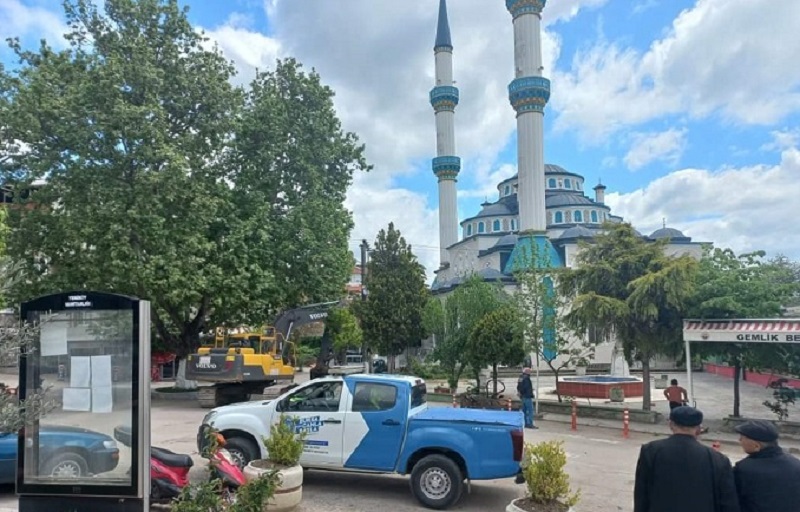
[237, 414, 306, 512]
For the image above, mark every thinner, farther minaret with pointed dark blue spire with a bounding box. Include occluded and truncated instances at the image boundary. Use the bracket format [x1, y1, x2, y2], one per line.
[430, 0, 461, 267]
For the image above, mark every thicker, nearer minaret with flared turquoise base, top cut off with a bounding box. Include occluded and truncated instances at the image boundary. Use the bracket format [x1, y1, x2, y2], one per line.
[505, 0, 560, 272]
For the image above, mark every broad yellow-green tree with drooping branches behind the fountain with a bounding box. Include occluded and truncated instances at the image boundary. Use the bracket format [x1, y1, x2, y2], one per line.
[559, 223, 697, 410]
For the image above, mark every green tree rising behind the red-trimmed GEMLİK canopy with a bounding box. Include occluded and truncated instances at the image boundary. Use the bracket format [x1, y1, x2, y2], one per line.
[688, 248, 796, 417]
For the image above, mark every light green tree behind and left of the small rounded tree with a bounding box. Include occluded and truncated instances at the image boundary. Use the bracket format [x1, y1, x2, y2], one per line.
[433, 274, 508, 389]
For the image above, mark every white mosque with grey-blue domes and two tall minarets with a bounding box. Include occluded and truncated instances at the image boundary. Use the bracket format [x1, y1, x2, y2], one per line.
[430, 0, 704, 375]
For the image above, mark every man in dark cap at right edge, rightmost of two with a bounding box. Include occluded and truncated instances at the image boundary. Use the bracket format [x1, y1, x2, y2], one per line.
[733, 420, 800, 512]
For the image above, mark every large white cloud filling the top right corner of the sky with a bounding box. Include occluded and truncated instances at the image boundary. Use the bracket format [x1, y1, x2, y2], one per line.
[553, 0, 800, 140]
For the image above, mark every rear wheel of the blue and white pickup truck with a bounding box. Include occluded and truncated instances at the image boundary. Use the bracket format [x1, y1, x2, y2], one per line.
[411, 455, 464, 510]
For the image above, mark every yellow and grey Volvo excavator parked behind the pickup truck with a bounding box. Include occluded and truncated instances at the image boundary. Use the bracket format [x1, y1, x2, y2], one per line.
[186, 302, 338, 408]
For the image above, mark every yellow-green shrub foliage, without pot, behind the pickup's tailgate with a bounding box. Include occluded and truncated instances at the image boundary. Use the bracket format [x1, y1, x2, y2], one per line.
[522, 441, 580, 507]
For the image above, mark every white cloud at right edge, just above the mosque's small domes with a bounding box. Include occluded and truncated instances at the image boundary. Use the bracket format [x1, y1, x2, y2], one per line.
[606, 146, 800, 258]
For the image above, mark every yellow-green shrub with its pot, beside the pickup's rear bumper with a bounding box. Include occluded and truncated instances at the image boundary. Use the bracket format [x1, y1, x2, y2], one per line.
[506, 441, 580, 512]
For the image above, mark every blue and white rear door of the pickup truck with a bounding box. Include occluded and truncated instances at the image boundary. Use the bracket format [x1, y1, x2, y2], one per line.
[343, 381, 408, 471]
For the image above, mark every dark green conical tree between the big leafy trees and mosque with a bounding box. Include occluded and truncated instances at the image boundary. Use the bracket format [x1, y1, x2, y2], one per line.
[357, 222, 429, 372]
